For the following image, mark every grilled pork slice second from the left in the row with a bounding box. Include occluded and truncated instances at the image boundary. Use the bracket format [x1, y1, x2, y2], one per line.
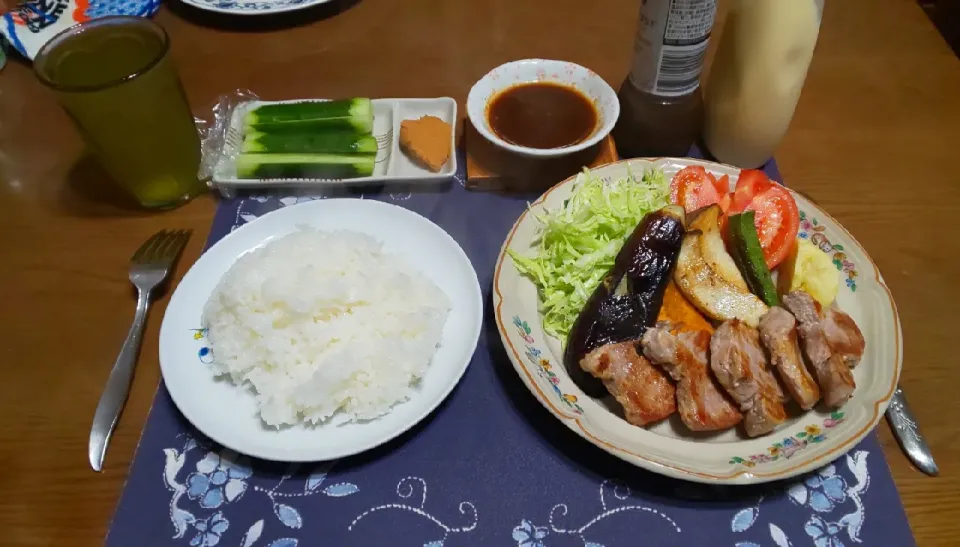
[641, 321, 743, 431]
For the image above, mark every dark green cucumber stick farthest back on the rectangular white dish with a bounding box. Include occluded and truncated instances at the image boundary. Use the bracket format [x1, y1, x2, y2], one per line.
[243, 98, 373, 135]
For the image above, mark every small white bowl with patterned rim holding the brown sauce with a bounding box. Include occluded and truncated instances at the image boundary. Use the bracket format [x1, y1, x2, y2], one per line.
[467, 59, 620, 158]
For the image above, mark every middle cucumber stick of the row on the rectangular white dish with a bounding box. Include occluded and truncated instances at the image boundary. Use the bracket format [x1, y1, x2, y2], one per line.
[241, 131, 377, 154]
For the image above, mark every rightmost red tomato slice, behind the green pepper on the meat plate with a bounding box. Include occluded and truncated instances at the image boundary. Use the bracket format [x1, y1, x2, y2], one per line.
[728, 169, 800, 269]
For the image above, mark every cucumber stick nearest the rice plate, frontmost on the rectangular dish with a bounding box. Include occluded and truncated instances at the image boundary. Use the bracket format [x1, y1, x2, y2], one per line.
[237, 154, 376, 179]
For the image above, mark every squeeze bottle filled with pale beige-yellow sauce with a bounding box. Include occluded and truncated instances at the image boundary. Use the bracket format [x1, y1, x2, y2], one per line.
[703, 0, 823, 168]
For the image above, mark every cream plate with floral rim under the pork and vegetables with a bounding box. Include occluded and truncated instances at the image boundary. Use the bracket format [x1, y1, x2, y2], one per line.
[493, 158, 903, 484]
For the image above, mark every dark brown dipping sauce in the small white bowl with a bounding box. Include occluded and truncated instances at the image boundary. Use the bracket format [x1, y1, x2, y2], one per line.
[487, 82, 597, 149]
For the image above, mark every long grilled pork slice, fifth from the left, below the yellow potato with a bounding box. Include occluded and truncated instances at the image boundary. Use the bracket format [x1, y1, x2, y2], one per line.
[783, 291, 857, 407]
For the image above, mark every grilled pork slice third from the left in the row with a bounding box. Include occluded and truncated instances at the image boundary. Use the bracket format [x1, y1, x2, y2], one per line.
[710, 319, 787, 437]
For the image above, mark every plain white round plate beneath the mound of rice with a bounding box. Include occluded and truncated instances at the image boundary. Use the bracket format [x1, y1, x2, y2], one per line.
[160, 199, 483, 461]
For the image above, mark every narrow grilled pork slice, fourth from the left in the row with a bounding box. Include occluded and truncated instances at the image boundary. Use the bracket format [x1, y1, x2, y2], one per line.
[760, 306, 820, 410]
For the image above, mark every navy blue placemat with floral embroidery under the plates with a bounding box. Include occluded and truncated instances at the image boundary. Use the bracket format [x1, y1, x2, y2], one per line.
[106, 152, 914, 547]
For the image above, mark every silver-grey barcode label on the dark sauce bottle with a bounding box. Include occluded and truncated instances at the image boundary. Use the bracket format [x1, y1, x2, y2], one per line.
[630, 0, 717, 97]
